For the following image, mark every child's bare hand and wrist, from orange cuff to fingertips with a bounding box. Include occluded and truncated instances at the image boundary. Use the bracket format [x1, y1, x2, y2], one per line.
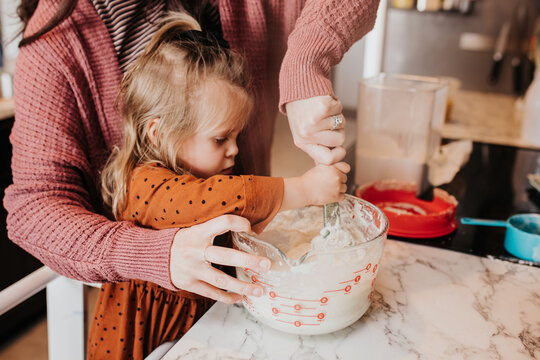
[281, 162, 351, 210]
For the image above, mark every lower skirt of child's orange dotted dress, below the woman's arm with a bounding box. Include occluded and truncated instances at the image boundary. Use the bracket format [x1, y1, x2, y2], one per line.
[87, 280, 213, 359]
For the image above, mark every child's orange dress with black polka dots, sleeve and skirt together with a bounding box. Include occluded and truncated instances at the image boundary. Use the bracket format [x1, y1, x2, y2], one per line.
[87, 165, 283, 360]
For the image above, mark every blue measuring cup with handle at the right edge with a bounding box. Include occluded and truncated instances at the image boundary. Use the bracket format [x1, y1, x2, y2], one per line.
[461, 214, 540, 262]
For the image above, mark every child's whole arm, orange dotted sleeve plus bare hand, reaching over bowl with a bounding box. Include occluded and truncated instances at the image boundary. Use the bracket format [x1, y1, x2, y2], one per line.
[121, 163, 350, 232]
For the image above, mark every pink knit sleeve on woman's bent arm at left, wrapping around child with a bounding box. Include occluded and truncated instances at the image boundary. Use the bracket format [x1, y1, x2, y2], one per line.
[4, 39, 177, 289]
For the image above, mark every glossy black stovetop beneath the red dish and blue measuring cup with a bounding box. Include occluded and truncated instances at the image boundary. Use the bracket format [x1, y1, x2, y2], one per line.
[354, 143, 540, 266]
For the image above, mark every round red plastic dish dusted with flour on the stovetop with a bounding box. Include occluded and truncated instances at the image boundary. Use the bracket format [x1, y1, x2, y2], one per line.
[356, 180, 457, 238]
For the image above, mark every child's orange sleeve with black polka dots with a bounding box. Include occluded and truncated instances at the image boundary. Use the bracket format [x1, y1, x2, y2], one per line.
[122, 166, 283, 233]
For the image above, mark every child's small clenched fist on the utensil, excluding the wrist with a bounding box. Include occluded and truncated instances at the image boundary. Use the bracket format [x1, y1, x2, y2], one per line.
[301, 162, 351, 205]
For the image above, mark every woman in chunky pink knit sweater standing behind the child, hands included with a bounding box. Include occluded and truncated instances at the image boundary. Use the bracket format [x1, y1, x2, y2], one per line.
[4, 0, 378, 346]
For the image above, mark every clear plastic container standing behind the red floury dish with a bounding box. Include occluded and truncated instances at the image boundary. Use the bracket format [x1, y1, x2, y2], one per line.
[355, 73, 448, 185]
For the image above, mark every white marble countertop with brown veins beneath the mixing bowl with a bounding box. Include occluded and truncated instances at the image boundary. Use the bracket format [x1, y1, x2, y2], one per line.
[164, 240, 540, 360]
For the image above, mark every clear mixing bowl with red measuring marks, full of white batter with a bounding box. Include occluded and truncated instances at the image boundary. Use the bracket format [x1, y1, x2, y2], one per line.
[233, 195, 388, 335]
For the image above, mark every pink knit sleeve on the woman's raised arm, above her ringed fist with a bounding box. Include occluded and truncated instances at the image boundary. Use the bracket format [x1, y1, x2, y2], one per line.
[279, 0, 379, 113]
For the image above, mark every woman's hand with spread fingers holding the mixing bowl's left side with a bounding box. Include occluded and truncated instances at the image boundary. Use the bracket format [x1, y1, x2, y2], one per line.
[170, 215, 271, 303]
